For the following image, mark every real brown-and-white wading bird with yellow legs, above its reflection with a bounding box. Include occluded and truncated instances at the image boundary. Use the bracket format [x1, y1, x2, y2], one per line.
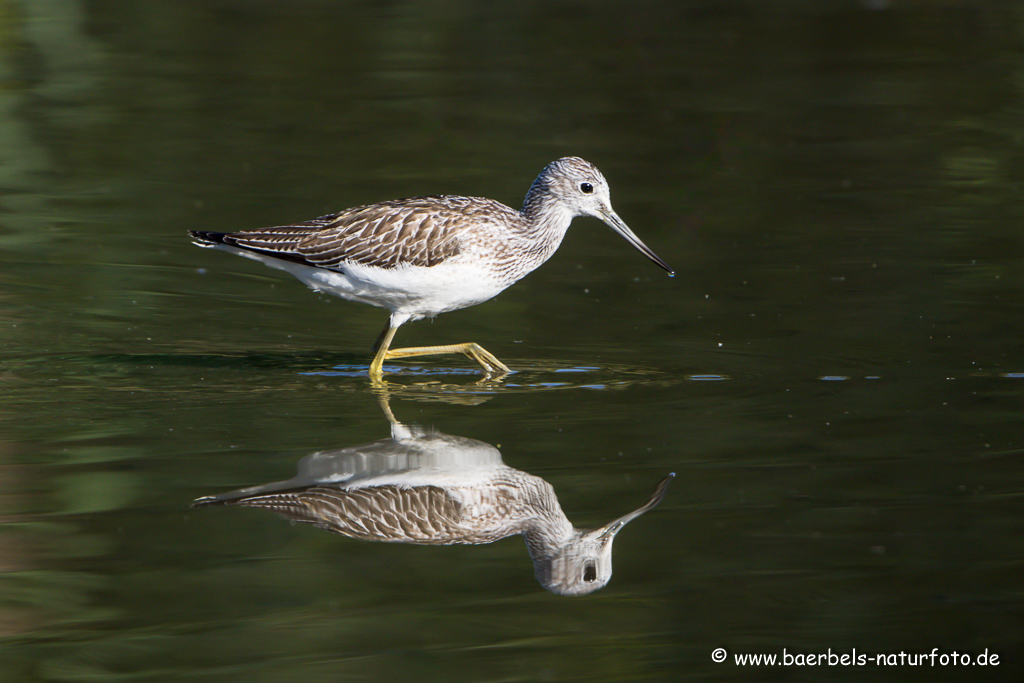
[188, 157, 674, 379]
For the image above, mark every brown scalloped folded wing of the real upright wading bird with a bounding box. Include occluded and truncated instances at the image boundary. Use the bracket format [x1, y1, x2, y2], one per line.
[193, 197, 517, 268]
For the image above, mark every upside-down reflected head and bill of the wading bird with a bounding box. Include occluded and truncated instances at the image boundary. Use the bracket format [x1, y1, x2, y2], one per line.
[527, 474, 676, 596]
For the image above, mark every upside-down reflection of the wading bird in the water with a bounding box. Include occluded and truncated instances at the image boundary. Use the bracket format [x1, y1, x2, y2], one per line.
[194, 423, 675, 595]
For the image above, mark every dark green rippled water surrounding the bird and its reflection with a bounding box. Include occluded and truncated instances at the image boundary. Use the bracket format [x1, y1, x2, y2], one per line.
[0, 0, 1024, 681]
